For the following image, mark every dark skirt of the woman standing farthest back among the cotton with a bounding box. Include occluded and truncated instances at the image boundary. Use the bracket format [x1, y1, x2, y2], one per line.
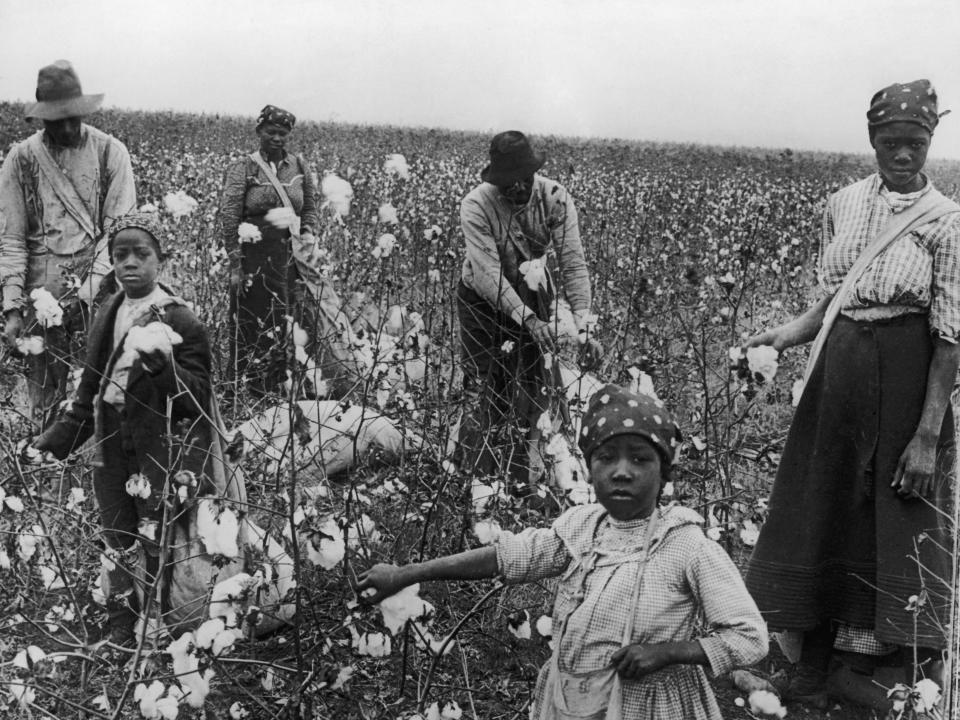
[230, 215, 297, 394]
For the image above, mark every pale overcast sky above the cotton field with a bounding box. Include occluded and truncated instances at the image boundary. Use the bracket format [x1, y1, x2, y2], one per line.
[0, 0, 960, 159]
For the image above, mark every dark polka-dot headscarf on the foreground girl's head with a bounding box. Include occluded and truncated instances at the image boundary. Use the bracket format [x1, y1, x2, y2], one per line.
[578, 385, 681, 465]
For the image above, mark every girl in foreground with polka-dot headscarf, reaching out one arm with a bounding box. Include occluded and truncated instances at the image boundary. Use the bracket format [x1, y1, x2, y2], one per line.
[357, 385, 767, 720]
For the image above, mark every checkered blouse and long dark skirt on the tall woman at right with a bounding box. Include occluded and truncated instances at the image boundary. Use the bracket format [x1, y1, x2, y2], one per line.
[746, 175, 960, 654]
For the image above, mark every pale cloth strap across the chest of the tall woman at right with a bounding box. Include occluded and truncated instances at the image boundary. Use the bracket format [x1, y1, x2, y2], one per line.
[803, 188, 960, 387]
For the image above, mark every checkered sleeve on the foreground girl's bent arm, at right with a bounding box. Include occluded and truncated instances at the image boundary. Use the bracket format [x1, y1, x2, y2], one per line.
[686, 537, 769, 675]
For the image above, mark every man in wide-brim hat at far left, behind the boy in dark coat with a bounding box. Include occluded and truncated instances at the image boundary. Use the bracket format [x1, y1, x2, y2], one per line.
[0, 60, 137, 423]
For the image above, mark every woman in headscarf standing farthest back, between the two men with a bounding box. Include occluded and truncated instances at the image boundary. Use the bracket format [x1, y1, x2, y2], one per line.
[220, 105, 318, 395]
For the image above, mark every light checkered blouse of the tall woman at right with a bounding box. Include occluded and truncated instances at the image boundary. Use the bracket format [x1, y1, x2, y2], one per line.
[820, 174, 960, 342]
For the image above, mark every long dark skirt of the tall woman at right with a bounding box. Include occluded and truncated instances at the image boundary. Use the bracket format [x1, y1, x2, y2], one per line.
[746, 315, 956, 648]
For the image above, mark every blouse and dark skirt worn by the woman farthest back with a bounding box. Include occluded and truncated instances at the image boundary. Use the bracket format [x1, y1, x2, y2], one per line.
[220, 153, 319, 391]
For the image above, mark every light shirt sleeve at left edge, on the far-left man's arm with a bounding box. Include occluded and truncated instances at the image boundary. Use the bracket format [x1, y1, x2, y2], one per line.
[0, 148, 27, 312]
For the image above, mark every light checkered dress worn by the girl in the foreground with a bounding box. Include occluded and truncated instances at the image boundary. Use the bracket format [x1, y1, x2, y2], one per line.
[497, 504, 767, 720]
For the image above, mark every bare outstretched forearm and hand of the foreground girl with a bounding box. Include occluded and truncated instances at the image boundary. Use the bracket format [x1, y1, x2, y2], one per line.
[356, 547, 498, 603]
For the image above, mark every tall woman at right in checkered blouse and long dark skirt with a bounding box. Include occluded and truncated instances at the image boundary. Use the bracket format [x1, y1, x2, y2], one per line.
[747, 80, 960, 706]
